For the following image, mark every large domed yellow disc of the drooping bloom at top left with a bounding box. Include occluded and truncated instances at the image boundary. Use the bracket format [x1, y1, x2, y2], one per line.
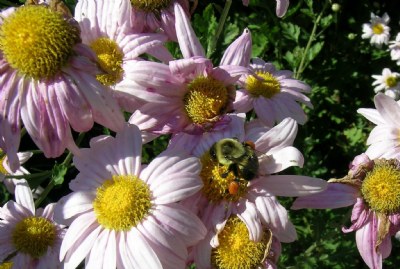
[0, 5, 80, 80]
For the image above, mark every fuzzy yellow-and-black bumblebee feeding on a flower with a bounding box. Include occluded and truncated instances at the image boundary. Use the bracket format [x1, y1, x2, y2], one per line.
[210, 138, 259, 181]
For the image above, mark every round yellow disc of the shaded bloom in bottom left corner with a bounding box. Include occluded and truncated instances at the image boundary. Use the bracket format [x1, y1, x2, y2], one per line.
[12, 217, 57, 258]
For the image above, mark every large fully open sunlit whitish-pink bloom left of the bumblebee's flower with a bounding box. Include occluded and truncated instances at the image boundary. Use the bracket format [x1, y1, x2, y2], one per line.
[56, 125, 206, 269]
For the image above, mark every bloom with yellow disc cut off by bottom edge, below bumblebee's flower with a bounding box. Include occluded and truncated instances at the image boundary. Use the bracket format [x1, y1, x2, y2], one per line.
[193, 216, 281, 269]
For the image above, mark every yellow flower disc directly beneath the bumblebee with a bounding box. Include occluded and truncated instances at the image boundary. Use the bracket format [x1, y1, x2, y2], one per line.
[200, 151, 247, 202]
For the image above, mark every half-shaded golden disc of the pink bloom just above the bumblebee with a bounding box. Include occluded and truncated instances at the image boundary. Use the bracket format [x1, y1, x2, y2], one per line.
[183, 77, 229, 124]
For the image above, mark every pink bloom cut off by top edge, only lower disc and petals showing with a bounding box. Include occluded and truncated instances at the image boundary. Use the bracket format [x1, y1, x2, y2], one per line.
[130, 0, 189, 41]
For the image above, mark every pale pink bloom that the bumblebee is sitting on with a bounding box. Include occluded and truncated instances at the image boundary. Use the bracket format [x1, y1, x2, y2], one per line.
[170, 114, 326, 242]
